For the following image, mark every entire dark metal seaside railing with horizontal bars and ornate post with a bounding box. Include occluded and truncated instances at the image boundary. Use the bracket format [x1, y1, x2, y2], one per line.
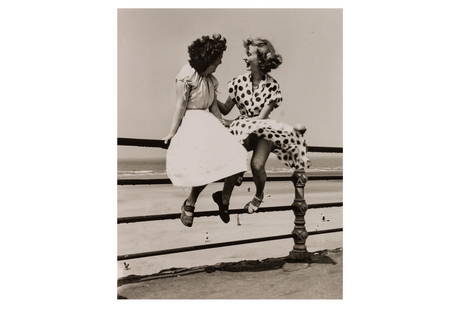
[117, 138, 343, 261]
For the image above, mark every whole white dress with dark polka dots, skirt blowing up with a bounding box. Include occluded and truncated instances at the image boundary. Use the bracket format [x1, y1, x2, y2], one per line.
[228, 73, 310, 170]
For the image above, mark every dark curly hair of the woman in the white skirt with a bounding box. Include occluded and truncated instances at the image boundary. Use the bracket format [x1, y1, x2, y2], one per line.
[187, 34, 226, 73]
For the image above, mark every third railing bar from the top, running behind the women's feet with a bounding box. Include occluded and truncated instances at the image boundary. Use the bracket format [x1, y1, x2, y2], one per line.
[118, 202, 342, 224]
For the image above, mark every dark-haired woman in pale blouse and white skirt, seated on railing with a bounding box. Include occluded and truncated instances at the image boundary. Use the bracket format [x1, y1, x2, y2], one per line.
[163, 35, 247, 227]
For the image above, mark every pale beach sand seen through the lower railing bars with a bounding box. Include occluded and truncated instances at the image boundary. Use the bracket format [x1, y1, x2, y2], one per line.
[118, 181, 343, 278]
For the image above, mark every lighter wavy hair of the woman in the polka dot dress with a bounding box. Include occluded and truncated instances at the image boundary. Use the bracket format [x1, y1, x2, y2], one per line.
[244, 38, 283, 74]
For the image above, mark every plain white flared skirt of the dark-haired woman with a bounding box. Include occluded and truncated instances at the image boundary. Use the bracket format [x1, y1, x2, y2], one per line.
[166, 110, 247, 187]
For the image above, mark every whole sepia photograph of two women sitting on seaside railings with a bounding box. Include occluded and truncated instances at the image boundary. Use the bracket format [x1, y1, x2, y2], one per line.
[116, 9, 343, 299]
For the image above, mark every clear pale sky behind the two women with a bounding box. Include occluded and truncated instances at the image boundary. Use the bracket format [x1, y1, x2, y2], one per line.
[117, 9, 342, 158]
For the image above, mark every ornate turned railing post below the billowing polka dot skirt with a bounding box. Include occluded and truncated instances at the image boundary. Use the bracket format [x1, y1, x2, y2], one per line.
[289, 125, 310, 261]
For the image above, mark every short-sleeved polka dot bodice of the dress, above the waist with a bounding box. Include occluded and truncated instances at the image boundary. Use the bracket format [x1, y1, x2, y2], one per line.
[228, 73, 282, 117]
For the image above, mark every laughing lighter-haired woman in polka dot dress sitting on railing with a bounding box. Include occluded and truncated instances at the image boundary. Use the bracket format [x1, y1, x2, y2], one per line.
[213, 38, 310, 213]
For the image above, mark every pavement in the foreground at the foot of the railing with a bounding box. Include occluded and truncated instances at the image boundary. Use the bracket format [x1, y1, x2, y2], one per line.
[118, 248, 342, 299]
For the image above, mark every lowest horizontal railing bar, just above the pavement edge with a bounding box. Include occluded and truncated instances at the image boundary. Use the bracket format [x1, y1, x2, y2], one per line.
[118, 228, 342, 261]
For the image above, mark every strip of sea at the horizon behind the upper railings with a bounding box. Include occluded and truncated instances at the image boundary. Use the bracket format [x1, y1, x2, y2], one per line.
[118, 153, 342, 179]
